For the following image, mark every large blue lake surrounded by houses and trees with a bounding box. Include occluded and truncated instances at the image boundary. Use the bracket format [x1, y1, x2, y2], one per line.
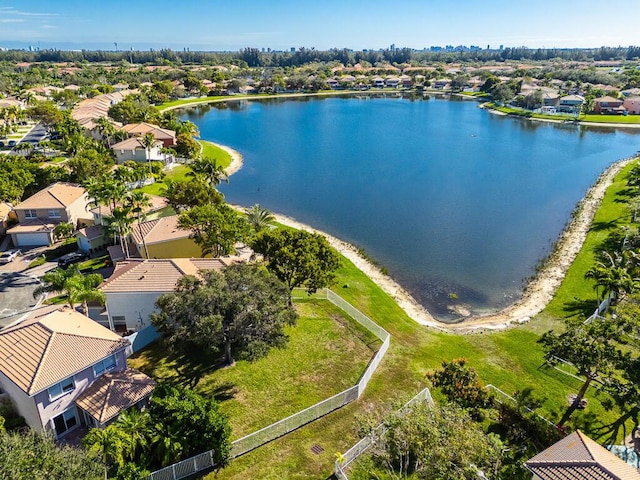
[182, 97, 640, 321]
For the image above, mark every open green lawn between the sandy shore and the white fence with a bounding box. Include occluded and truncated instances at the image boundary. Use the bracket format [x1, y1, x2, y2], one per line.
[207, 163, 630, 480]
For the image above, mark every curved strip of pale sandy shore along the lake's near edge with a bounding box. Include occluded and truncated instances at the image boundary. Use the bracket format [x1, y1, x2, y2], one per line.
[231, 152, 633, 333]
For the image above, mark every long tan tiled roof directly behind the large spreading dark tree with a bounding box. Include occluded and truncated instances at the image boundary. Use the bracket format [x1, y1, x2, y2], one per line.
[100, 257, 240, 293]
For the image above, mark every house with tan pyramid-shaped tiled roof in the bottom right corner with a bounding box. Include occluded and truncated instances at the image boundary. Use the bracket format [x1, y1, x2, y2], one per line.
[524, 430, 640, 480]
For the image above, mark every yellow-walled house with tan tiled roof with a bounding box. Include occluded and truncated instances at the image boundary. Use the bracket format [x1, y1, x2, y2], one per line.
[131, 215, 202, 258]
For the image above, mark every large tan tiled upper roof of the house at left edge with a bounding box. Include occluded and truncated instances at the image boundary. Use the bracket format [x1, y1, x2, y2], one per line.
[0, 305, 129, 396]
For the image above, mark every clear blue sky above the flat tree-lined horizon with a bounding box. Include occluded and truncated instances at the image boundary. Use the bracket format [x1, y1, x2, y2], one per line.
[0, 0, 640, 50]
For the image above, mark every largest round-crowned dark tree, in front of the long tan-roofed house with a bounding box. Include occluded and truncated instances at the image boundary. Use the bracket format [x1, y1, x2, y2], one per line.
[152, 264, 296, 364]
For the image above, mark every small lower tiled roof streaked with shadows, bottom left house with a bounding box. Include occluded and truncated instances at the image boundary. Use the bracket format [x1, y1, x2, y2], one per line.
[75, 368, 156, 423]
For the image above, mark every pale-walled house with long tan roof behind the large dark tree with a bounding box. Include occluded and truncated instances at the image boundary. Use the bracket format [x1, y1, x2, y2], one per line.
[98, 255, 248, 332]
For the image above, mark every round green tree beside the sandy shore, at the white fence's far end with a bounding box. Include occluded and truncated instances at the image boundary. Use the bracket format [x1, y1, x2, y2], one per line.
[251, 230, 340, 293]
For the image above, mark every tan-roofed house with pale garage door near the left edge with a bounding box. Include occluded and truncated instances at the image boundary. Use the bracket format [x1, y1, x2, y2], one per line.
[7, 182, 92, 247]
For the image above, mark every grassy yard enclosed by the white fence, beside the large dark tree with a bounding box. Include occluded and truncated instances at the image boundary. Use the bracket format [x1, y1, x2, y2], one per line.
[129, 299, 380, 438]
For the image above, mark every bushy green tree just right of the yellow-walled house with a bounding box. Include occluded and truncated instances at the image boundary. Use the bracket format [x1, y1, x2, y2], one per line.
[178, 203, 249, 257]
